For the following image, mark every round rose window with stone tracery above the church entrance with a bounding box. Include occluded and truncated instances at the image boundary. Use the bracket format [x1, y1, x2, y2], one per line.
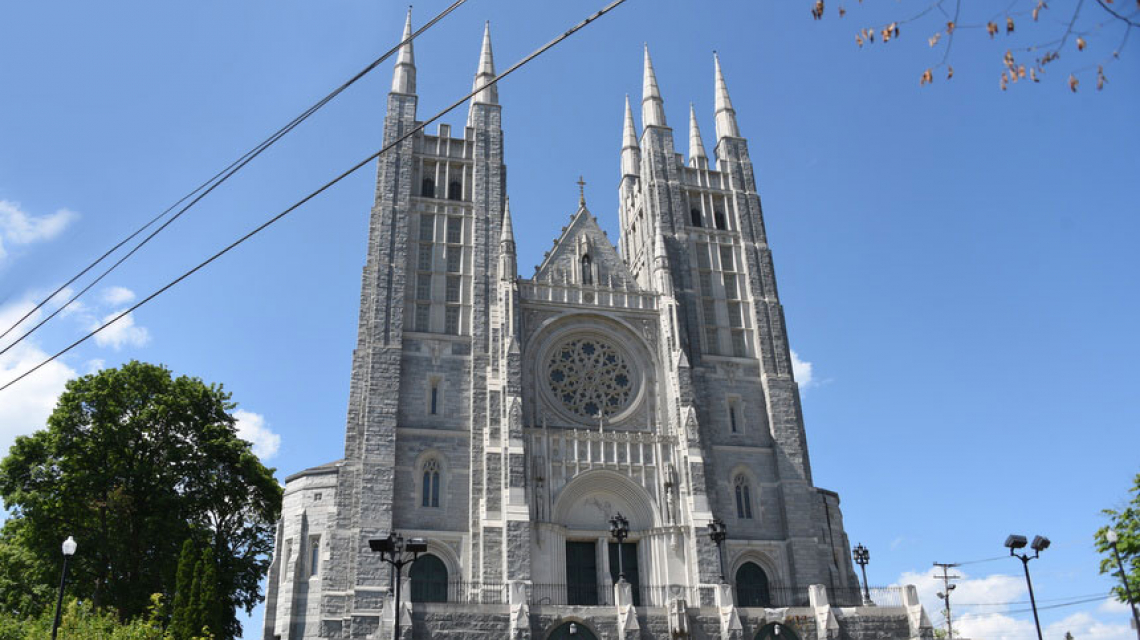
[546, 337, 637, 419]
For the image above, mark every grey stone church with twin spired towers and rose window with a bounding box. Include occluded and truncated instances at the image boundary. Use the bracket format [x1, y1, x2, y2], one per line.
[263, 16, 930, 640]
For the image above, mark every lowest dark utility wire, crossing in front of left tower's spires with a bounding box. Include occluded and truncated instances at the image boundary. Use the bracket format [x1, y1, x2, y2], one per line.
[0, 0, 626, 391]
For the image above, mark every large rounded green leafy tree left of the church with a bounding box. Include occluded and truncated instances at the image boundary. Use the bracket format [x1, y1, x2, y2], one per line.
[0, 362, 282, 638]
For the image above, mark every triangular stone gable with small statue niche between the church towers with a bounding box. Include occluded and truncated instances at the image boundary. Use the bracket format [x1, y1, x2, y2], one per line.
[535, 204, 637, 289]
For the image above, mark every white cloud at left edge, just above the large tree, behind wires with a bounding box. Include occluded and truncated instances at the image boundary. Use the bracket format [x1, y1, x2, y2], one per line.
[0, 300, 76, 456]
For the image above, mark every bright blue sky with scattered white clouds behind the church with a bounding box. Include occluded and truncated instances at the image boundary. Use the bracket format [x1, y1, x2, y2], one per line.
[0, 0, 1140, 640]
